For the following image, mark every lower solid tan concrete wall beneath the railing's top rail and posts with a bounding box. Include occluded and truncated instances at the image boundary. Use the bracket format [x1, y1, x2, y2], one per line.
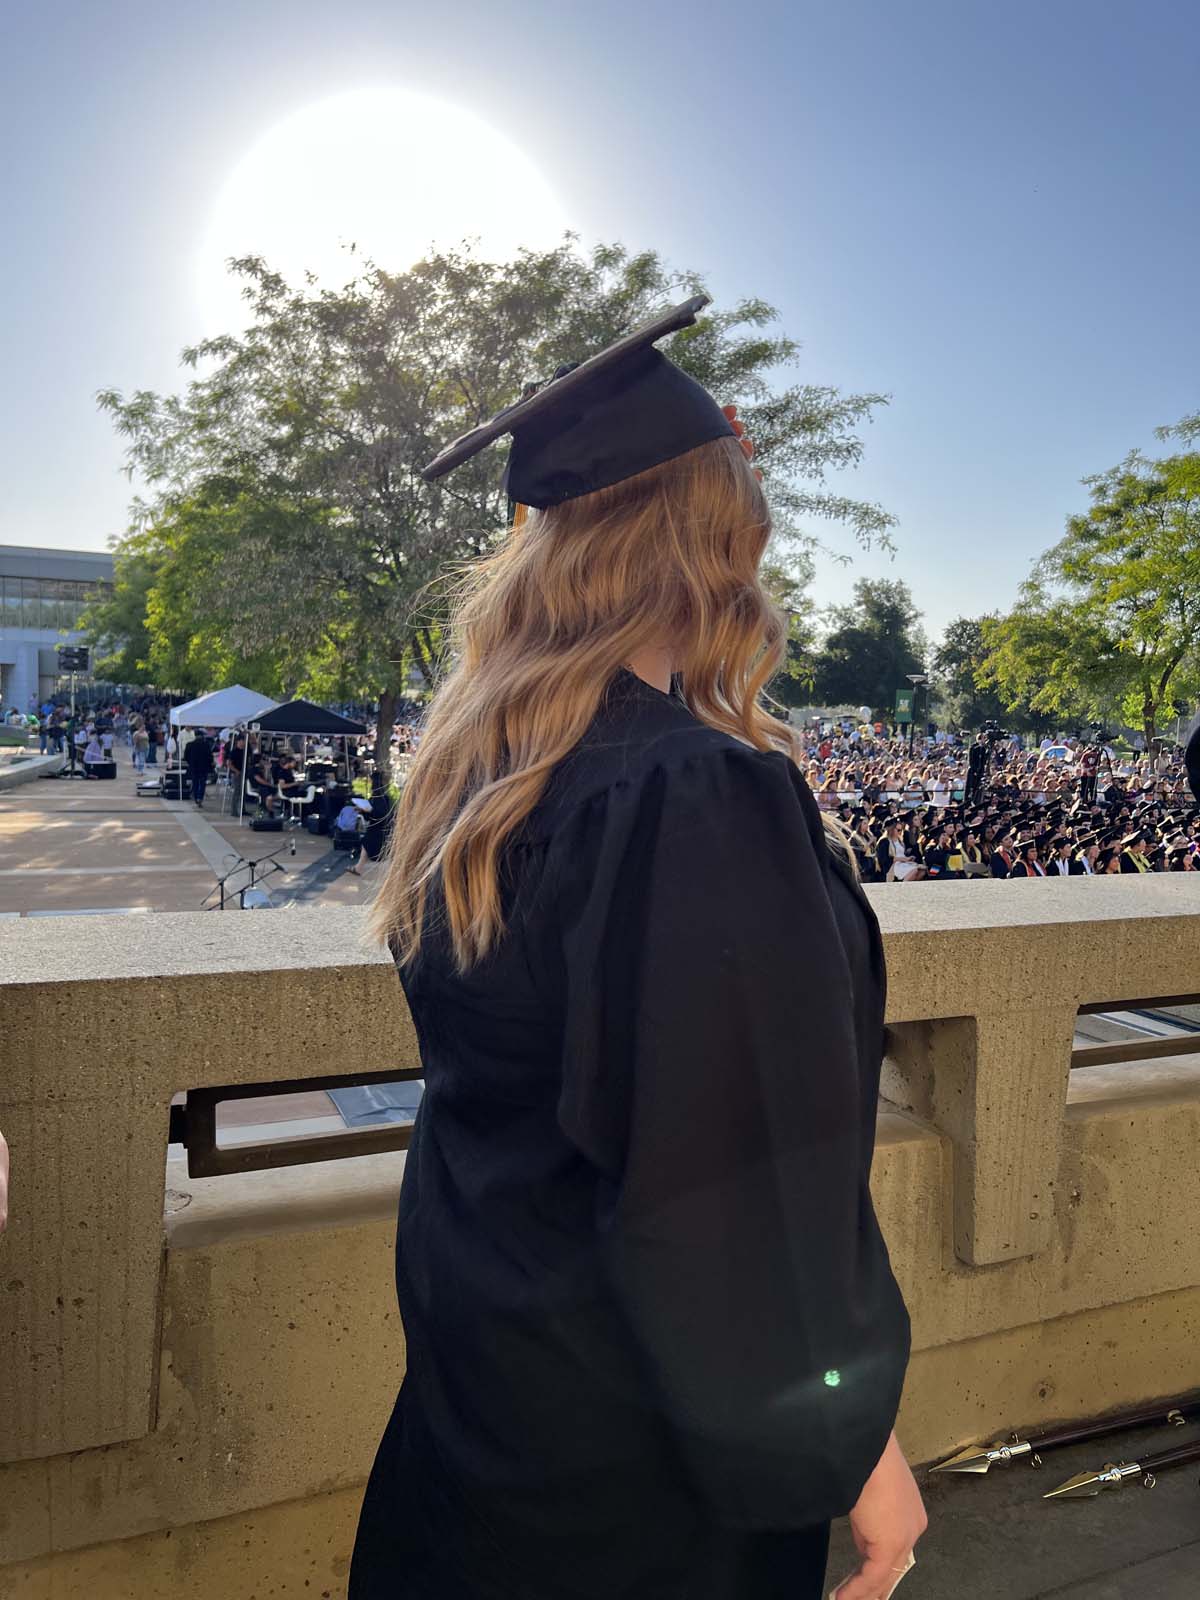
[0, 1062, 1200, 1561]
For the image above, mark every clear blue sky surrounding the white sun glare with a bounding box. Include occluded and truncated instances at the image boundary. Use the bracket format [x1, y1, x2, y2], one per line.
[0, 0, 1200, 634]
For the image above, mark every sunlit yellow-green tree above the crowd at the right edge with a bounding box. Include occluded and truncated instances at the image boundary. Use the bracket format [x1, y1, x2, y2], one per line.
[981, 432, 1200, 744]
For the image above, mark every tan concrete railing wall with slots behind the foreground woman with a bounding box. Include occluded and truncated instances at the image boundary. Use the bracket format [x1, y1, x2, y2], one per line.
[0, 875, 1200, 1600]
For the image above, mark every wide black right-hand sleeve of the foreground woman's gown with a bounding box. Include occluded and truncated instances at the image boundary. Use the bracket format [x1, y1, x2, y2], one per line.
[558, 746, 909, 1530]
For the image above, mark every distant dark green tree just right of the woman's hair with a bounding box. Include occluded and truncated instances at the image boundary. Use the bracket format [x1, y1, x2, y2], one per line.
[813, 578, 928, 720]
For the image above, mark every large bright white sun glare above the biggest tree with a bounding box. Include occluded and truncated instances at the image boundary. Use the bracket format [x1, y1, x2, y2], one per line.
[197, 90, 568, 334]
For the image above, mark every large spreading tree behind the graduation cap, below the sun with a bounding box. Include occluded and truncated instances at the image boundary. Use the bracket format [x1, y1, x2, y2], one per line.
[99, 242, 893, 749]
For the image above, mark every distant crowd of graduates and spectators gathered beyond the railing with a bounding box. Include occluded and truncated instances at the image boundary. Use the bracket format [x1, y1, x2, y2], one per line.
[5, 696, 1200, 883]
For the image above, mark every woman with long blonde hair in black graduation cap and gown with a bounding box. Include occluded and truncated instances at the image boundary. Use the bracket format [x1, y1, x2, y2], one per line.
[349, 299, 925, 1600]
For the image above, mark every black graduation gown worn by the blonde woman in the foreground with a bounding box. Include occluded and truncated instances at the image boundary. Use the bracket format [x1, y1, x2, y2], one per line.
[349, 672, 909, 1600]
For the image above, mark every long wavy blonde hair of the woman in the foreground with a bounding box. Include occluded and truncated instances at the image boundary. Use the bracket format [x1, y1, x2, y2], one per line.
[371, 438, 853, 971]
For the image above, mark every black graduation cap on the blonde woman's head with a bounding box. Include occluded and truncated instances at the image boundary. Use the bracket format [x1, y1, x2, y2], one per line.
[421, 294, 734, 510]
